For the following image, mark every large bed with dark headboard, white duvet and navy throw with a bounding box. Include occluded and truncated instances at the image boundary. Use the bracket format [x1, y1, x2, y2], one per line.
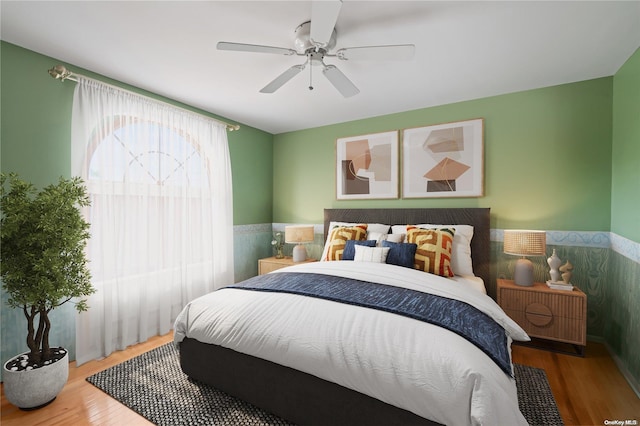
[174, 208, 528, 425]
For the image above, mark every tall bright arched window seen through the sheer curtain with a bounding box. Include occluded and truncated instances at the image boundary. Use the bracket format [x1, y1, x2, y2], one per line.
[88, 118, 216, 280]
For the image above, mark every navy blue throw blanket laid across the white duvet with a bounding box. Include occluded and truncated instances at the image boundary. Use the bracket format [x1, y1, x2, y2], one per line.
[224, 272, 513, 377]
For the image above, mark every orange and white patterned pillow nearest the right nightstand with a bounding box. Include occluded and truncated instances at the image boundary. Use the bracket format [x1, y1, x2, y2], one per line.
[407, 225, 455, 278]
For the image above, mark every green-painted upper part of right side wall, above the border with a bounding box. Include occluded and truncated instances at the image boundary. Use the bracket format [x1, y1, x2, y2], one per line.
[611, 49, 640, 243]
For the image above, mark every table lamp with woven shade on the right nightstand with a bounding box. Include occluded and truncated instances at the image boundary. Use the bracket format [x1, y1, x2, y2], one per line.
[504, 229, 547, 287]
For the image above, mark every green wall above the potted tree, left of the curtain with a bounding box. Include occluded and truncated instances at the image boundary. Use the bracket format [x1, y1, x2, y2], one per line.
[0, 42, 73, 187]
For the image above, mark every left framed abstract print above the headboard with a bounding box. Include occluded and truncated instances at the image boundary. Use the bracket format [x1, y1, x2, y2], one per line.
[336, 130, 400, 200]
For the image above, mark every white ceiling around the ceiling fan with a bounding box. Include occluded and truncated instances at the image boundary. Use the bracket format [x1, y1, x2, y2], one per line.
[0, 0, 640, 134]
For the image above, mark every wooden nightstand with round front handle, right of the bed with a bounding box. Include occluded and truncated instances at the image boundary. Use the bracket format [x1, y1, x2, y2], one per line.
[498, 279, 587, 356]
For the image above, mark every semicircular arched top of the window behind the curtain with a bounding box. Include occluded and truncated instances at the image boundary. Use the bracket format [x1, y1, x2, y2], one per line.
[88, 121, 208, 188]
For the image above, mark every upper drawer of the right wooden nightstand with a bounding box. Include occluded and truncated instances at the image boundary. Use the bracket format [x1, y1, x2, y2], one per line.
[500, 288, 586, 320]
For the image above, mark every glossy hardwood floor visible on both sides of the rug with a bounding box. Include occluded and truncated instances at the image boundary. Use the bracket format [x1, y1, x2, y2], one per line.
[0, 333, 640, 426]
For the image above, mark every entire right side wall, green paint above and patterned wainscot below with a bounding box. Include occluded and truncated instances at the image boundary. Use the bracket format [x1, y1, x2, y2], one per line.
[603, 49, 640, 394]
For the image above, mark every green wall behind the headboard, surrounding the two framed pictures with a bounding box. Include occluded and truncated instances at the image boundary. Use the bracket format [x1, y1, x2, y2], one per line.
[273, 77, 613, 231]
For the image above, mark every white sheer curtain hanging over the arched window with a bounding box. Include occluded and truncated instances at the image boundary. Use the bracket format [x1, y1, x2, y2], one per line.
[72, 77, 233, 364]
